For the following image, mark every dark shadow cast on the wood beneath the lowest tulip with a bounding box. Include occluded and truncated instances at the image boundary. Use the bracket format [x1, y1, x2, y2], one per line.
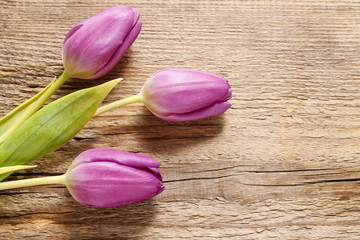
[54, 199, 157, 239]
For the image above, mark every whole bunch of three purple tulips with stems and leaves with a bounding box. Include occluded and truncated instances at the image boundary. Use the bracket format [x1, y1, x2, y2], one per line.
[0, 6, 232, 208]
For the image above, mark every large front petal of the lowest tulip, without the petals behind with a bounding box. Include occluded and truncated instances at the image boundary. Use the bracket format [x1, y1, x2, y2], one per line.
[65, 162, 164, 208]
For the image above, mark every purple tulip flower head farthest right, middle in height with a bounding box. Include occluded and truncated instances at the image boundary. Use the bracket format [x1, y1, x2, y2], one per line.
[140, 68, 232, 122]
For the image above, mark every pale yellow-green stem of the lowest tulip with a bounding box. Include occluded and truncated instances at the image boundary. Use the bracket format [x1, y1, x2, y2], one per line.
[0, 174, 65, 190]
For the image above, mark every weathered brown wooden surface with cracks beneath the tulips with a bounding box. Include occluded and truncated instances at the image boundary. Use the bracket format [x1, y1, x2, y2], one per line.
[0, 0, 360, 239]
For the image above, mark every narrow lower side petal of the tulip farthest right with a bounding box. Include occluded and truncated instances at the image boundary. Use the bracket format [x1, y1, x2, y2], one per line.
[154, 102, 231, 122]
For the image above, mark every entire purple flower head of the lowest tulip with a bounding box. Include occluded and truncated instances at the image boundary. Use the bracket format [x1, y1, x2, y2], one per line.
[64, 148, 165, 208]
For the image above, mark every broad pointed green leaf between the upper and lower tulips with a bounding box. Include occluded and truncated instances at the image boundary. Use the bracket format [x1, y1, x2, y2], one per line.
[0, 79, 121, 180]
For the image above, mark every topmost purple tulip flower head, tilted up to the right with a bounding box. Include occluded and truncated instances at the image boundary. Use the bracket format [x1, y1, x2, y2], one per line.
[63, 6, 141, 79]
